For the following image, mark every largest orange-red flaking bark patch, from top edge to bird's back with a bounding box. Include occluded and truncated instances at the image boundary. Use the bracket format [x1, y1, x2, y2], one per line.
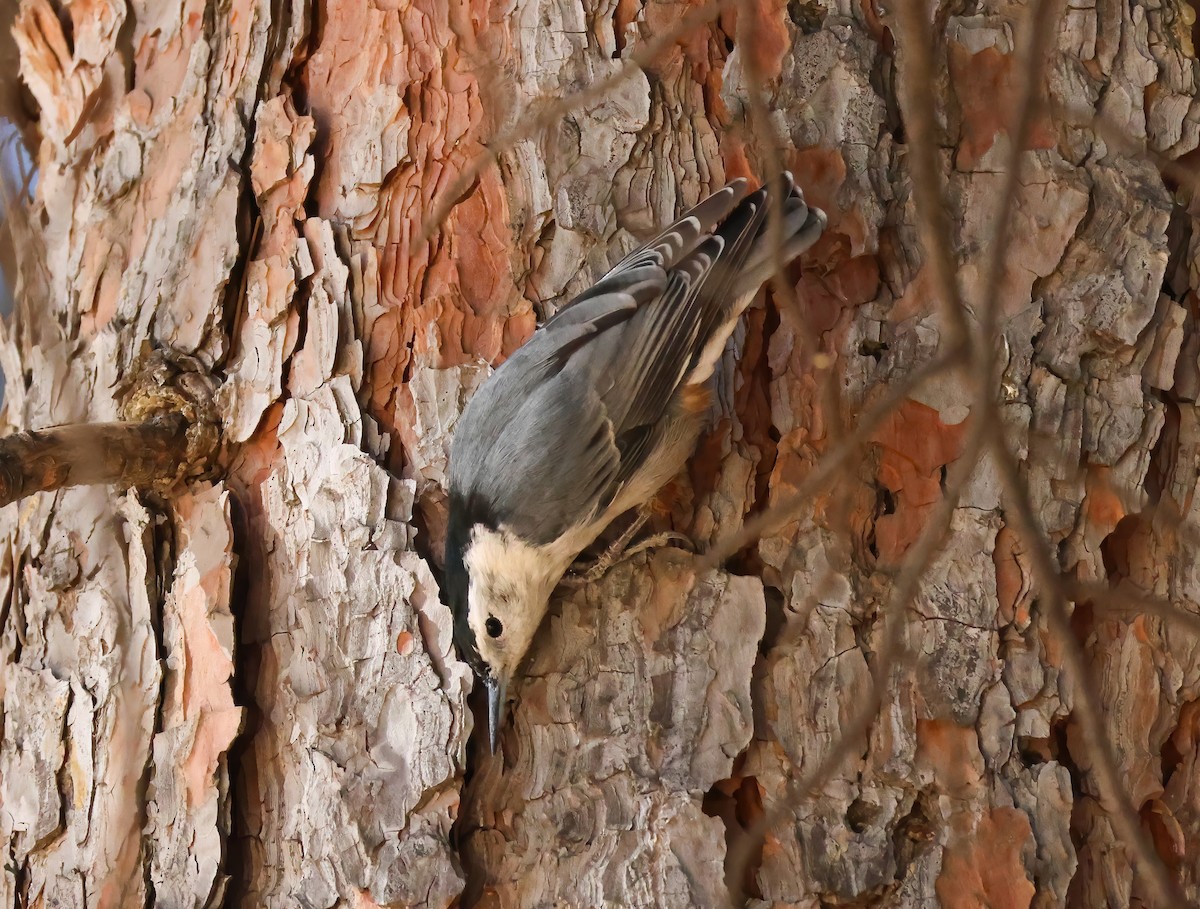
[304, 0, 534, 441]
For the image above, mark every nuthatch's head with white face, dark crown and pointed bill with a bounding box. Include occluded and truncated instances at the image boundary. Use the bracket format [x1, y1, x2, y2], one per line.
[445, 505, 560, 752]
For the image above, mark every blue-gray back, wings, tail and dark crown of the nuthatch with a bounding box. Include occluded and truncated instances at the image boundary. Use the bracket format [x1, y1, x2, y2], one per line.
[446, 175, 824, 700]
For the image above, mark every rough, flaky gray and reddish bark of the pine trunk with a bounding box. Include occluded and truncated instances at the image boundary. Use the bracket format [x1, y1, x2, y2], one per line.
[0, 0, 1200, 909]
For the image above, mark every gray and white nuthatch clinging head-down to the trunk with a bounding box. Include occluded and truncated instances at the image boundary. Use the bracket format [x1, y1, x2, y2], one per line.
[443, 173, 826, 753]
